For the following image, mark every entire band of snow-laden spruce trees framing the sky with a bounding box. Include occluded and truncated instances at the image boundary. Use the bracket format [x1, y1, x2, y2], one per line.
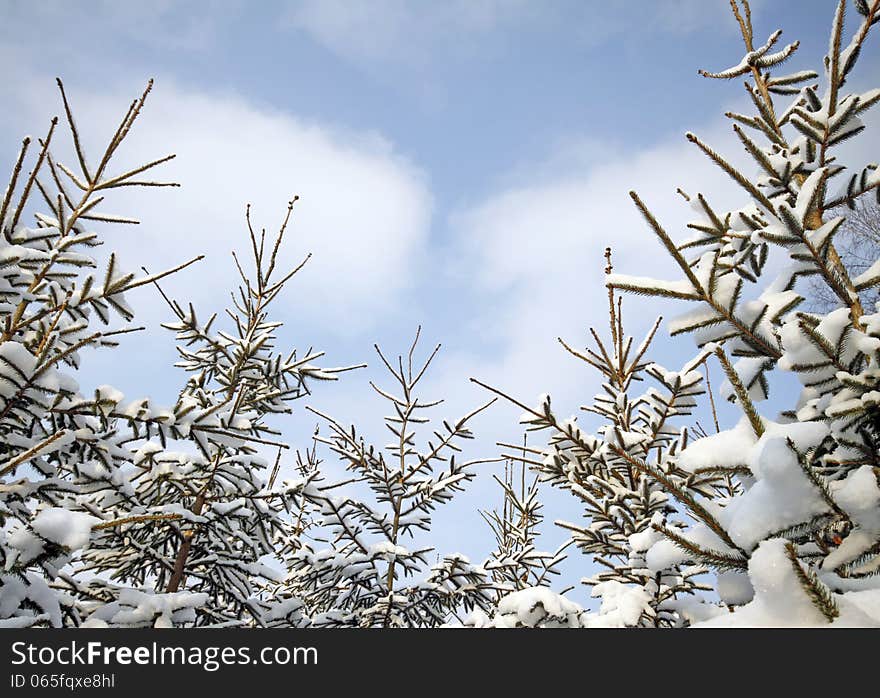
[0, 0, 880, 628]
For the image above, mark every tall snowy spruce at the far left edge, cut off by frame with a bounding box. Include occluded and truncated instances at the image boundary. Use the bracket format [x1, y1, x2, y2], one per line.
[0, 80, 201, 627]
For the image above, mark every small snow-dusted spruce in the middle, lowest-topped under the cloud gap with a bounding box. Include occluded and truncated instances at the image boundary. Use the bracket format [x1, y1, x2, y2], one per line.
[280, 332, 498, 627]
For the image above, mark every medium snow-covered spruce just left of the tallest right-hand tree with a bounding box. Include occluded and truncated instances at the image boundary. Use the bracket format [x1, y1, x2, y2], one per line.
[481, 248, 723, 627]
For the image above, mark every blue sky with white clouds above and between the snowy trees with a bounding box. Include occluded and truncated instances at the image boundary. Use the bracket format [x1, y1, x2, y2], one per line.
[0, 0, 878, 600]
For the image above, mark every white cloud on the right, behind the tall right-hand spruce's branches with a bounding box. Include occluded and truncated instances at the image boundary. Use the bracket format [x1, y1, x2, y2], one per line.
[436, 117, 741, 422]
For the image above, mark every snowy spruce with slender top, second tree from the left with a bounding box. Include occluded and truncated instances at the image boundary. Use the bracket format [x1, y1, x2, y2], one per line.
[71, 197, 348, 626]
